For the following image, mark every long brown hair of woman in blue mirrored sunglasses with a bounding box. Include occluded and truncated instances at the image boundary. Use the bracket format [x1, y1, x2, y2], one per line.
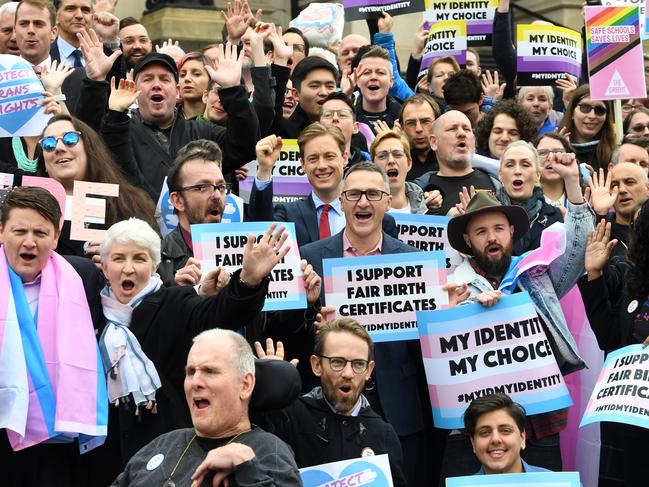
[36, 114, 158, 233]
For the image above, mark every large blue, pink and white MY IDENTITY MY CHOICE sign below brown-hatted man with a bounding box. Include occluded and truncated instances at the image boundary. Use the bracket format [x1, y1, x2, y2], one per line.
[417, 292, 572, 429]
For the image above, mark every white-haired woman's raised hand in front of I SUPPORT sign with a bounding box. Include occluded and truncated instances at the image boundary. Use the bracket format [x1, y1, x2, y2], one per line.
[239, 223, 290, 287]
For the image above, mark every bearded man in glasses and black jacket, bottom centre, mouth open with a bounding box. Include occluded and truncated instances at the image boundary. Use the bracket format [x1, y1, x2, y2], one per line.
[254, 318, 407, 487]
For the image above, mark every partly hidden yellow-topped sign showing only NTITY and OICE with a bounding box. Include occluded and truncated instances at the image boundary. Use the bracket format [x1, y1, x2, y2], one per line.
[419, 20, 466, 75]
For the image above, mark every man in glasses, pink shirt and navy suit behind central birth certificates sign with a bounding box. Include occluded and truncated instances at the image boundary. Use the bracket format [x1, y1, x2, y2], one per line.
[300, 162, 434, 485]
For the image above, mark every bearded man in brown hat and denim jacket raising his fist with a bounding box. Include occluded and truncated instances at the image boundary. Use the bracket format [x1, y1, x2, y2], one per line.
[443, 189, 594, 478]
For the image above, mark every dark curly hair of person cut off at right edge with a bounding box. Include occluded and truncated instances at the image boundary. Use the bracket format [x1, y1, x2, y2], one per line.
[627, 200, 649, 300]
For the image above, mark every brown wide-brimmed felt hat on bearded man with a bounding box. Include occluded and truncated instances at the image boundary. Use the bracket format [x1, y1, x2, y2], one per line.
[447, 191, 530, 255]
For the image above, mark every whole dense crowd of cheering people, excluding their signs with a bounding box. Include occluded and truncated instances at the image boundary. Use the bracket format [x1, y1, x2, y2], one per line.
[0, 0, 649, 487]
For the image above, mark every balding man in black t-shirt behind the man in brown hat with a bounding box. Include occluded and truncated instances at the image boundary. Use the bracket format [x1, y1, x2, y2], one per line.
[415, 110, 500, 215]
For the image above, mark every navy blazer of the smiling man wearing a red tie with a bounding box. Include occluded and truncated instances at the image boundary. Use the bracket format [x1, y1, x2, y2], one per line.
[248, 182, 398, 246]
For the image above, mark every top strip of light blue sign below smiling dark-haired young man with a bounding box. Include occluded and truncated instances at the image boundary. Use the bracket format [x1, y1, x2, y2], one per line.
[446, 472, 581, 487]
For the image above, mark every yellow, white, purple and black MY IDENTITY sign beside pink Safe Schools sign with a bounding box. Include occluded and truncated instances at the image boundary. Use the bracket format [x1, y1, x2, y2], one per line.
[516, 24, 581, 86]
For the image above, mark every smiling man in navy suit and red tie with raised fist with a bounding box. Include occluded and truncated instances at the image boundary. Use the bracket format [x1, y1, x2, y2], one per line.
[248, 122, 397, 247]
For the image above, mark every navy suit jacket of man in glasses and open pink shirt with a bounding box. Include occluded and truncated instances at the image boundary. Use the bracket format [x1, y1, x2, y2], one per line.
[300, 232, 432, 436]
